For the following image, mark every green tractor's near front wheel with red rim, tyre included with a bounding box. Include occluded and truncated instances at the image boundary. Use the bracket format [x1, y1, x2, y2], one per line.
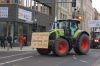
[53, 38, 69, 56]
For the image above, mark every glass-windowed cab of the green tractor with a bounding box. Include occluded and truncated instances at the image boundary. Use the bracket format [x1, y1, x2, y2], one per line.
[52, 19, 79, 37]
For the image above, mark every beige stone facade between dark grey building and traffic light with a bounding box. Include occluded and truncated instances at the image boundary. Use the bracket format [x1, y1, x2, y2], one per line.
[55, 0, 72, 20]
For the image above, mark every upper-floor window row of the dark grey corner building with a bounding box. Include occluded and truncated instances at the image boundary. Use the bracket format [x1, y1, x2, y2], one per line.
[0, 0, 51, 15]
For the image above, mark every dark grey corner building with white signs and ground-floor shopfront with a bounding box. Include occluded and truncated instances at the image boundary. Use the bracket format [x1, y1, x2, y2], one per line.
[0, 0, 55, 45]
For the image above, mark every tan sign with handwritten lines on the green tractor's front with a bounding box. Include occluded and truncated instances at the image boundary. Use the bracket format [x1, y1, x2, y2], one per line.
[31, 32, 49, 48]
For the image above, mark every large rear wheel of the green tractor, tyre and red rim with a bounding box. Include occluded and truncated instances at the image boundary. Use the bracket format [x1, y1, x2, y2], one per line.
[74, 34, 89, 55]
